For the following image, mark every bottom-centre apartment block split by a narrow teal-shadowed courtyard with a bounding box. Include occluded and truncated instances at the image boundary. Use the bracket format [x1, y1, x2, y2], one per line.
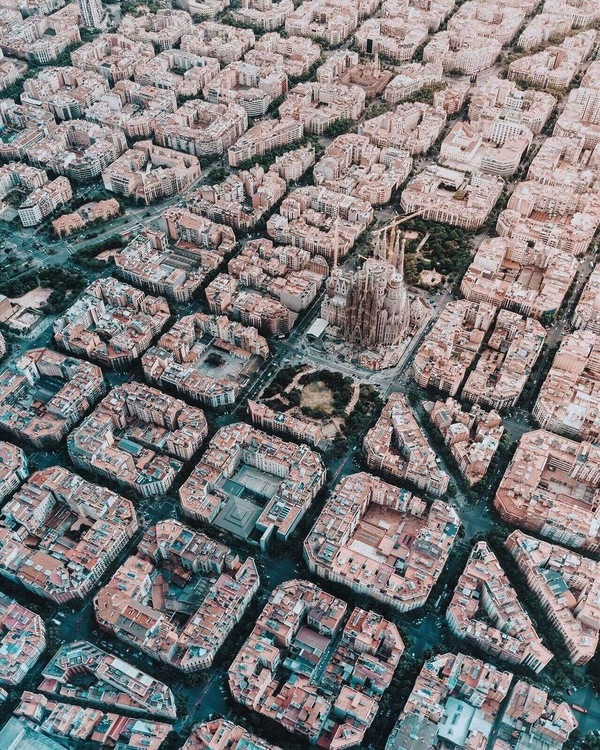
[228, 580, 404, 748]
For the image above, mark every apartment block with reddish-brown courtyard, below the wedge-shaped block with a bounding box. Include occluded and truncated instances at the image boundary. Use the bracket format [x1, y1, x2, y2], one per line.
[304, 472, 460, 612]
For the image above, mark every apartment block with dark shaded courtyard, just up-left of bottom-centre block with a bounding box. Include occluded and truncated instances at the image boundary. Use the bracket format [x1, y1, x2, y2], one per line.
[94, 519, 260, 673]
